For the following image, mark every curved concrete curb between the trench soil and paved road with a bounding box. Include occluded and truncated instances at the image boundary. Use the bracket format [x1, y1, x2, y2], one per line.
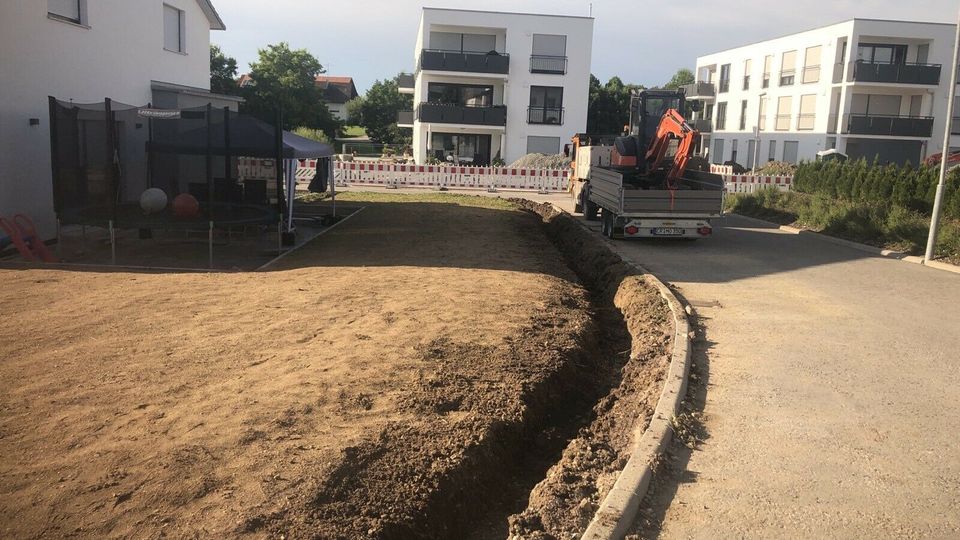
[552, 205, 691, 540]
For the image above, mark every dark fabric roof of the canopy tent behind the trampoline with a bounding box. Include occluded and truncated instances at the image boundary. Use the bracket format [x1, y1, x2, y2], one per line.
[148, 113, 333, 159]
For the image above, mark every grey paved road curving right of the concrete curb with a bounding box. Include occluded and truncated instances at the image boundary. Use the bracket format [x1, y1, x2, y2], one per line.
[576, 213, 960, 538]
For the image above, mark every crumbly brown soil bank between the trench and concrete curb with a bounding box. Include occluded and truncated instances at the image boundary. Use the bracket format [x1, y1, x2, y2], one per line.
[510, 202, 673, 538]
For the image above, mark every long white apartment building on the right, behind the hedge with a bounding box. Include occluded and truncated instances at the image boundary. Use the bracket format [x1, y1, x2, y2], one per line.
[687, 19, 960, 168]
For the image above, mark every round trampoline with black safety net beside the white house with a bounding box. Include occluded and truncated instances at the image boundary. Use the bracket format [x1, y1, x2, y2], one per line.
[49, 97, 333, 267]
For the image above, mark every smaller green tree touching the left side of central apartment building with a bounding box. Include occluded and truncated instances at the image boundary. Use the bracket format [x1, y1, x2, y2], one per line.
[347, 77, 413, 144]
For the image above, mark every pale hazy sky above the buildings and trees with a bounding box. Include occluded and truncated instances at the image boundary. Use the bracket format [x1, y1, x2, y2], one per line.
[211, 0, 960, 93]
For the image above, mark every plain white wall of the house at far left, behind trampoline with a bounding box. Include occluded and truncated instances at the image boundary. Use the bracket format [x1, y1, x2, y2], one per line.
[0, 0, 239, 237]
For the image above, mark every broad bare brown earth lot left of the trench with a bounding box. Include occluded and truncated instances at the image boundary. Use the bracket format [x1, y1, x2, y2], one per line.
[0, 194, 591, 537]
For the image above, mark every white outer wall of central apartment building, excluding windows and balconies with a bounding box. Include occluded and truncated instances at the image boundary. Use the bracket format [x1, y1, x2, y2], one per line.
[413, 8, 593, 163]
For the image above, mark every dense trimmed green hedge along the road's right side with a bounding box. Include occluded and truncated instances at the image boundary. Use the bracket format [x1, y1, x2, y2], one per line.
[793, 159, 960, 219]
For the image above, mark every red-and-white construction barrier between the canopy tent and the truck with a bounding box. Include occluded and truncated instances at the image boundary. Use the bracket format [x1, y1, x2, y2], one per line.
[334, 161, 568, 192]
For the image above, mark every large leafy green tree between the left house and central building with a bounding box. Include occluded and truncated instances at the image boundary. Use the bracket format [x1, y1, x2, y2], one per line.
[241, 43, 341, 137]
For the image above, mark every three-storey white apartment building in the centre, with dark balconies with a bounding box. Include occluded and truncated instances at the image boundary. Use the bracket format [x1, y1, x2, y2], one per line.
[397, 8, 593, 164]
